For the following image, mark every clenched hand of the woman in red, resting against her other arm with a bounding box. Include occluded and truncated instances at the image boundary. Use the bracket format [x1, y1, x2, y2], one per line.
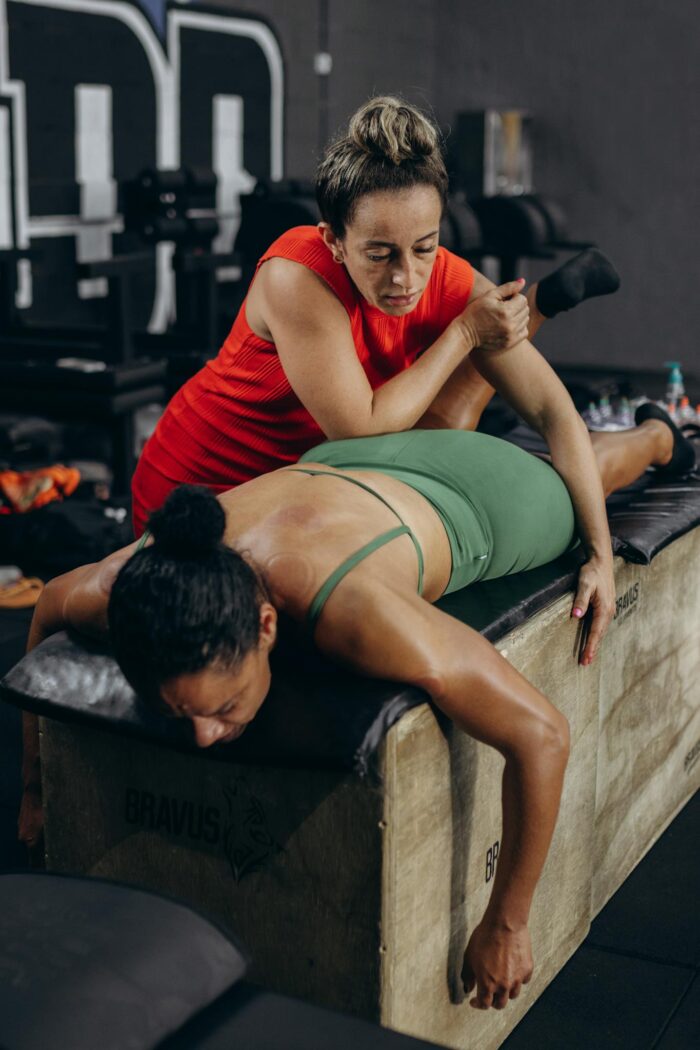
[457, 278, 530, 350]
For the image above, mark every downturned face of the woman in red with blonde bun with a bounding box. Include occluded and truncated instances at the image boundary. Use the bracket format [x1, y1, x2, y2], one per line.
[319, 186, 442, 317]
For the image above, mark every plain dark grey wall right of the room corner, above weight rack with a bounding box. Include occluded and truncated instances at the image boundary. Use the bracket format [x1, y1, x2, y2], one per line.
[436, 0, 700, 372]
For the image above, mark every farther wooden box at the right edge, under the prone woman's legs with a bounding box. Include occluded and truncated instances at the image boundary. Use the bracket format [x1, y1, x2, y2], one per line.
[591, 528, 700, 918]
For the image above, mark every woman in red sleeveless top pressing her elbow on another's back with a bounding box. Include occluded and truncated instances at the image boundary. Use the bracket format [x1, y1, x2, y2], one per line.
[132, 99, 528, 536]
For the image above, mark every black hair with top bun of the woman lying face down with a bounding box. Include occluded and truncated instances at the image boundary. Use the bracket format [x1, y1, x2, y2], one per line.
[108, 485, 267, 706]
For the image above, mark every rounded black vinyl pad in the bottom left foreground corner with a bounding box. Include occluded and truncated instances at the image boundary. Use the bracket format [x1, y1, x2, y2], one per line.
[0, 874, 247, 1050]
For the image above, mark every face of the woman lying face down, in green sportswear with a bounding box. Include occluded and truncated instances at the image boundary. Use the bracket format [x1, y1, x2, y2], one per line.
[161, 602, 277, 748]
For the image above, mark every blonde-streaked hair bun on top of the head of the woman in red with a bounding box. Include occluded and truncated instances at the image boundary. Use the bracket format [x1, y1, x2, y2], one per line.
[347, 95, 440, 165]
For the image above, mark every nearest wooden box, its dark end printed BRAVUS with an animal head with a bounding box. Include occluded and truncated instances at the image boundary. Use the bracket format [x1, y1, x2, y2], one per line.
[42, 595, 599, 1050]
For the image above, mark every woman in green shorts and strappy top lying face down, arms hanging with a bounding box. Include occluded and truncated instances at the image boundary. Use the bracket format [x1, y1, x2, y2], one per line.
[25, 419, 688, 1008]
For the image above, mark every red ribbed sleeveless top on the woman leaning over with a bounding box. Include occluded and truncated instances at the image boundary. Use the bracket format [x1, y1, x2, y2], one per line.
[132, 226, 473, 534]
